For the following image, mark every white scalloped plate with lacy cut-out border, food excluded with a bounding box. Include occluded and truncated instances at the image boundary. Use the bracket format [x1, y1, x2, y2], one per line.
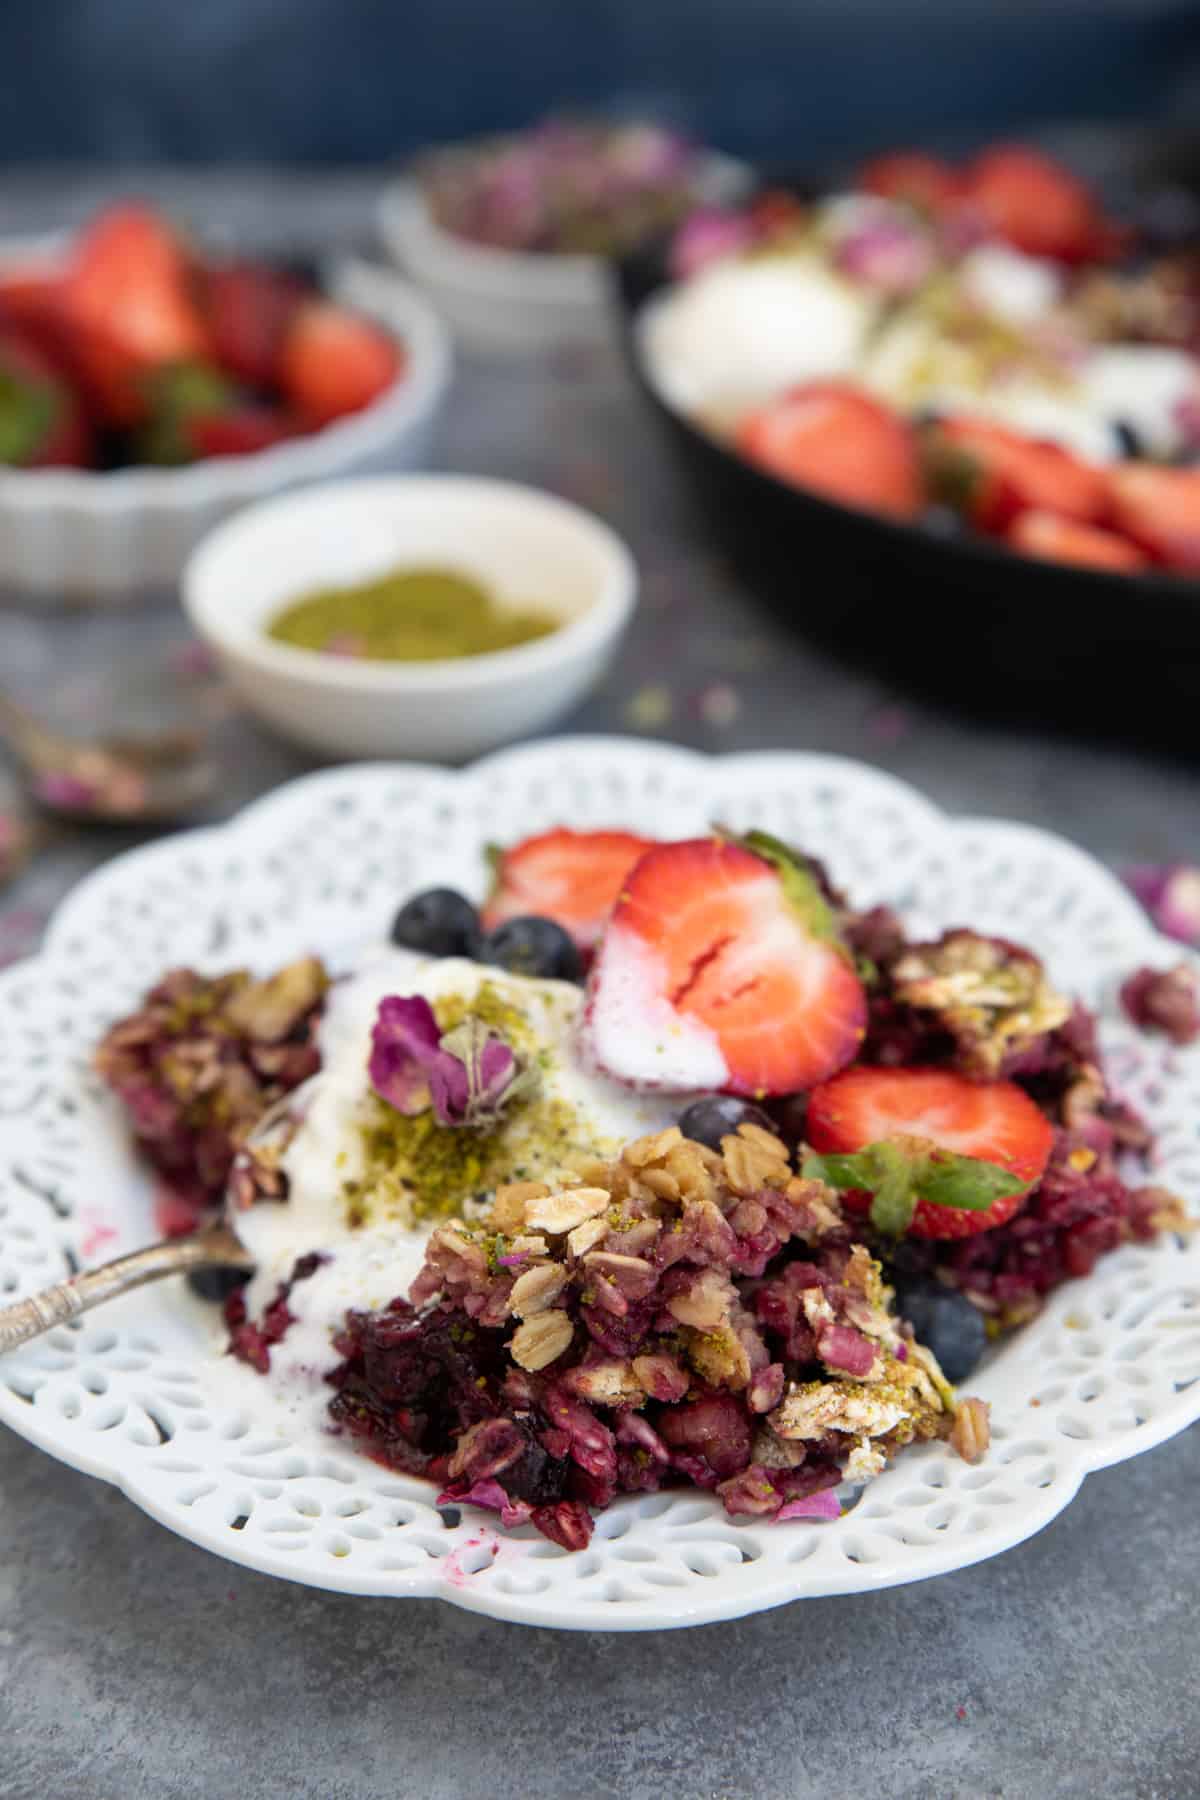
[0, 738, 1200, 1631]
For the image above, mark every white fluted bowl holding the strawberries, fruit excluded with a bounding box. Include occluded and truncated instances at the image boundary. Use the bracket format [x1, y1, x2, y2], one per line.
[0, 239, 452, 607]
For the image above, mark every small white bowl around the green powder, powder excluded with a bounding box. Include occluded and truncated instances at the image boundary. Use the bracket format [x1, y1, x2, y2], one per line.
[184, 475, 637, 761]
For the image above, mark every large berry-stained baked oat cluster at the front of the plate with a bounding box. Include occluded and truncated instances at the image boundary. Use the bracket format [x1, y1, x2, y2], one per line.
[323, 1123, 986, 1548]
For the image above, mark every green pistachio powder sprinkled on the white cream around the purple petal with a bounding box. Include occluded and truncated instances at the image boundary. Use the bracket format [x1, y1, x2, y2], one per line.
[342, 983, 615, 1228]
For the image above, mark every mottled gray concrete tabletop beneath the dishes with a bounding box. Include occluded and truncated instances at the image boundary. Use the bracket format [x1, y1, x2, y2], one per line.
[0, 173, 1200, 1800]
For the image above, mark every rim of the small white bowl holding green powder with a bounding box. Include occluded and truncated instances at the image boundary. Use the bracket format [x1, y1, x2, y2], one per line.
[182, 473, 637, 695]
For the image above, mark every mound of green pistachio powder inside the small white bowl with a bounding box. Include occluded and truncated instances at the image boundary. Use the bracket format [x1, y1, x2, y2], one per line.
[266, 569, 560, 662]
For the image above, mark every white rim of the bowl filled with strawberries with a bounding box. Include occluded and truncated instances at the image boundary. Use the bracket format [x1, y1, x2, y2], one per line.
[0, 236, 453, 517]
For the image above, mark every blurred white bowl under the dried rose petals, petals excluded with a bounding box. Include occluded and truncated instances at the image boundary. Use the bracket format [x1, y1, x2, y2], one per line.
[378, 155, 750, 355]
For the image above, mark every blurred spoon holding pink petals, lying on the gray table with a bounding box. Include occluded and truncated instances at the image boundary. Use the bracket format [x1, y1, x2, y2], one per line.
[0, 691, 216, 824]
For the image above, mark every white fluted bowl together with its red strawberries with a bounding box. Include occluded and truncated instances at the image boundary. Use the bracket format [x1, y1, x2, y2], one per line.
[0, 202, 450, 601]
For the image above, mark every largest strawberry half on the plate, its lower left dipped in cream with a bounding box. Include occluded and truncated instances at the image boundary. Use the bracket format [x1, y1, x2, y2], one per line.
[587, 833, 867, 1096]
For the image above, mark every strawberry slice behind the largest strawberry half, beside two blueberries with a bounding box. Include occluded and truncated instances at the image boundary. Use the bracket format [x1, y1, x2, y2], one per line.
[482, 828, 653, 950]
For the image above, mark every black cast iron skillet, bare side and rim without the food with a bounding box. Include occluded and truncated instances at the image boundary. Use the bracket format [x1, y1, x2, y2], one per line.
[615, 162, 1200, 754]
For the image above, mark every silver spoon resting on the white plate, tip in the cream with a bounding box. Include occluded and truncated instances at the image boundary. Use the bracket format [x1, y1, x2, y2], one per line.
[0, 1075, 318, 1354]
